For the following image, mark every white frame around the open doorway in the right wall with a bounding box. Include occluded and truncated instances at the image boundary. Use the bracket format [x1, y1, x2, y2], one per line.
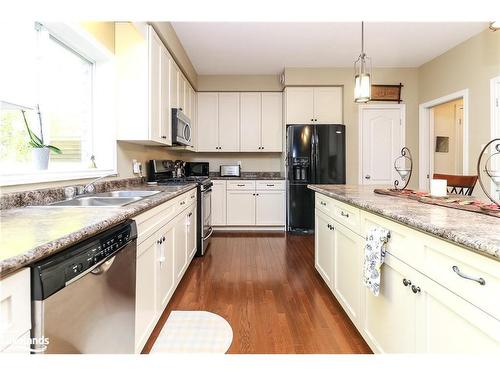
[418, 89, 469, 190]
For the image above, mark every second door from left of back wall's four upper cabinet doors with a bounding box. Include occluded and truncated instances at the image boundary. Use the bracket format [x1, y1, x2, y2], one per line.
[219, 92, 240, 152]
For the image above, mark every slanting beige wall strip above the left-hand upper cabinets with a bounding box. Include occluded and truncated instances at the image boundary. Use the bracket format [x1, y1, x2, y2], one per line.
[152, 22, 198, 90]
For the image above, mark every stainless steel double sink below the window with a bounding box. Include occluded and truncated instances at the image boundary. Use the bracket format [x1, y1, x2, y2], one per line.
[50, 190, 160, 207]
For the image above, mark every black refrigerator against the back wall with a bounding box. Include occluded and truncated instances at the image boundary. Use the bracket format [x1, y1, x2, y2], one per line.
[286, 125, 346, 232]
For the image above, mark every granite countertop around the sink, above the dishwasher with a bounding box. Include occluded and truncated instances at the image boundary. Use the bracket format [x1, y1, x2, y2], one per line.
[0, 184, 196, 276]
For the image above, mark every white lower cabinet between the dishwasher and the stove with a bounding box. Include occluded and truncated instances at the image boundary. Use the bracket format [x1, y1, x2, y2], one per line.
[134, 190, 196, 353]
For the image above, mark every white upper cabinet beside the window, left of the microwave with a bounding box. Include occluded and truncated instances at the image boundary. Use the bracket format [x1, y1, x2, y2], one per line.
[115, 22, 172, 146]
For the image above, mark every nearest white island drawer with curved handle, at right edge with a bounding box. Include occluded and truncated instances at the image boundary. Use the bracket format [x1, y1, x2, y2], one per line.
[421, 237, 500, 320]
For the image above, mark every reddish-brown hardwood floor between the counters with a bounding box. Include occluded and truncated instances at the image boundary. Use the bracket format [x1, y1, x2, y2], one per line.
[143, 233, 371, 354]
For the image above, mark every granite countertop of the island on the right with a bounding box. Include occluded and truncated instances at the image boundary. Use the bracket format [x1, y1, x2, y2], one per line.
[308, 185, 500, 261]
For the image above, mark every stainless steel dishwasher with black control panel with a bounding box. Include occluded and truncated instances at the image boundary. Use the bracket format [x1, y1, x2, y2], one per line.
[31, 220, 137, 354]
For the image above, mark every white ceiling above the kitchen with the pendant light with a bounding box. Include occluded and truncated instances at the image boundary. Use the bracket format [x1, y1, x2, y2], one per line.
[172, 22, 488, 75]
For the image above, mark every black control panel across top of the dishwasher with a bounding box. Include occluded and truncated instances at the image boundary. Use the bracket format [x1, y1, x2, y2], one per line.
[31, 221, 137, 300]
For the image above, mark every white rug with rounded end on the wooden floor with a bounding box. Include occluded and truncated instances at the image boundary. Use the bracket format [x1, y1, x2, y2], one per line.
[151, 311, 233, 354]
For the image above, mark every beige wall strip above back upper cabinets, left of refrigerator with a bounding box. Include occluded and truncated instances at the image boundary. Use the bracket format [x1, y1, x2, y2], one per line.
[198, 75, 283, 91]
